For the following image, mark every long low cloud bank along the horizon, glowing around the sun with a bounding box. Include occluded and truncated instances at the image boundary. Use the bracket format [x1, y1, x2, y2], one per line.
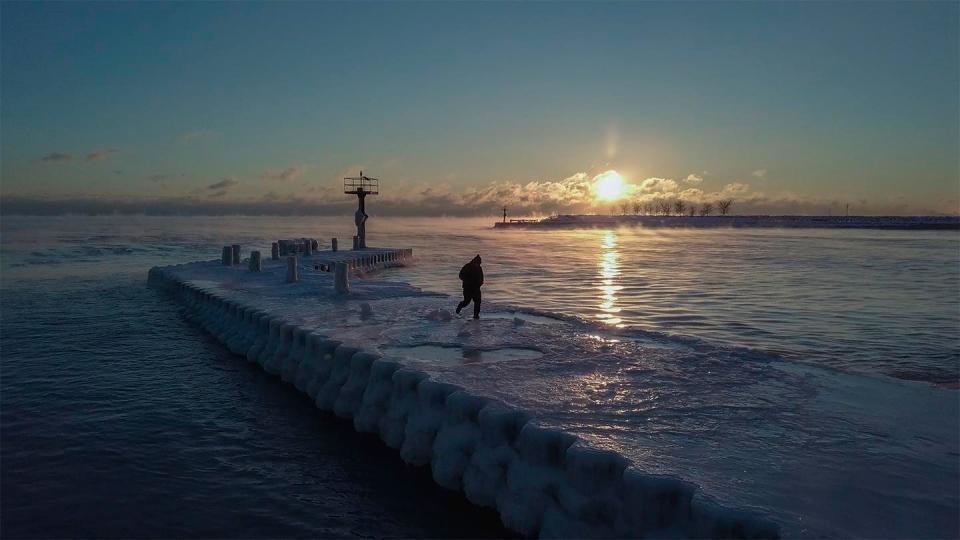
[0, 169, 960, 217]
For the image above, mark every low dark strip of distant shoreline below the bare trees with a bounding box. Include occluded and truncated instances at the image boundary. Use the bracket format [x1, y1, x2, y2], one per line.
[494, 215, 960, 230]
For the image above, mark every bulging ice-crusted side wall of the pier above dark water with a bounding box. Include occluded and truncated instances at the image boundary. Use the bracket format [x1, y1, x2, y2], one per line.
[149, 252, 779, 538]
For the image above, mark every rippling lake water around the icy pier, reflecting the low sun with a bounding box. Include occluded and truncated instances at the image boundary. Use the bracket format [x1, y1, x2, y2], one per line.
[0, 216, 960, 537]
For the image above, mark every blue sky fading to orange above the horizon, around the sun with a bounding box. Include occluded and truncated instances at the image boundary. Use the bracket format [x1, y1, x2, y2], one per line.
[0, 1, 960, 215]
